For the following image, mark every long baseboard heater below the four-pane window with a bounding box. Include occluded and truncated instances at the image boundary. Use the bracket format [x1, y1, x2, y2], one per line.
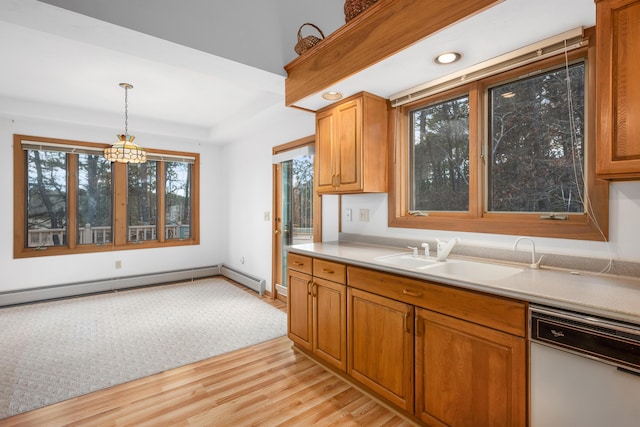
[0, 265, 220, 307]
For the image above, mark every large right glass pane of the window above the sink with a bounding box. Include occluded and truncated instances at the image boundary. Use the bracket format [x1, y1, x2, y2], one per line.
[488, 63, 585, 212]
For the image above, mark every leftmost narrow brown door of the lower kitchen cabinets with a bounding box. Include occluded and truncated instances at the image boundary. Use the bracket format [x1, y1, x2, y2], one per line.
[287, 269, 313, 351]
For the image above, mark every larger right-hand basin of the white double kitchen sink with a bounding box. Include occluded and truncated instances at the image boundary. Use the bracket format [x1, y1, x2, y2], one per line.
[417, 259, 524, 281]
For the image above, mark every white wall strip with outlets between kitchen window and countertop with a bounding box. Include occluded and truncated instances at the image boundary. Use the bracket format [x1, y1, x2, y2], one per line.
[341, 186, 640, 262]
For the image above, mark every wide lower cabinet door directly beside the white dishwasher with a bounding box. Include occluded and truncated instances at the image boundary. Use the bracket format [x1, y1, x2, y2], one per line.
[416, 308, 527, 427]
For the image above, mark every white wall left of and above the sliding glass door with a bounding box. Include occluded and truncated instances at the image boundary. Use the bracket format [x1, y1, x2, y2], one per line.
[224, 105, 315, 291]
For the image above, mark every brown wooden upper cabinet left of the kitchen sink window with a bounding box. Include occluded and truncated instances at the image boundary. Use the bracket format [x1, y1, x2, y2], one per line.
[315, 92, 387, 194]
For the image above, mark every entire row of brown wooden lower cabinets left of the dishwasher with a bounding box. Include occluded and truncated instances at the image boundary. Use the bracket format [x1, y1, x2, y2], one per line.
[288, 259, 528, 427]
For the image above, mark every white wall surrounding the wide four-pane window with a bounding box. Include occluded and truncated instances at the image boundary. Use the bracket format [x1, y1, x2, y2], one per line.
[0, 117, 227, 292]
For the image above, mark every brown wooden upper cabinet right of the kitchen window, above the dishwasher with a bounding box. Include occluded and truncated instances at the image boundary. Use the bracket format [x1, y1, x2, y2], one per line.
[596, 0, 640, 179]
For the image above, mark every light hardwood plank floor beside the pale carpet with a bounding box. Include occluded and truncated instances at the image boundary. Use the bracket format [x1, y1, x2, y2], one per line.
[0, 282, 412, 427]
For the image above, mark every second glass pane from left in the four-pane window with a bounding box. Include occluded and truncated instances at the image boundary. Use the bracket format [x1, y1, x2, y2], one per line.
[77, 154, 113, 245]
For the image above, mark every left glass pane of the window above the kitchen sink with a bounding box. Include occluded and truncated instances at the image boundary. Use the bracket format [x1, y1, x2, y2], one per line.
[409, 96, 469, 211]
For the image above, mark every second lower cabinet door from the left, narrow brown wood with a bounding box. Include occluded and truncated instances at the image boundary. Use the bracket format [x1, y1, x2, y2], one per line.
[311, 277, 347, 371]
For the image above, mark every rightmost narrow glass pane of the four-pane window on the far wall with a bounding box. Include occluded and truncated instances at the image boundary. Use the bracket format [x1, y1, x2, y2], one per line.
[164, 162, 191, 240]
